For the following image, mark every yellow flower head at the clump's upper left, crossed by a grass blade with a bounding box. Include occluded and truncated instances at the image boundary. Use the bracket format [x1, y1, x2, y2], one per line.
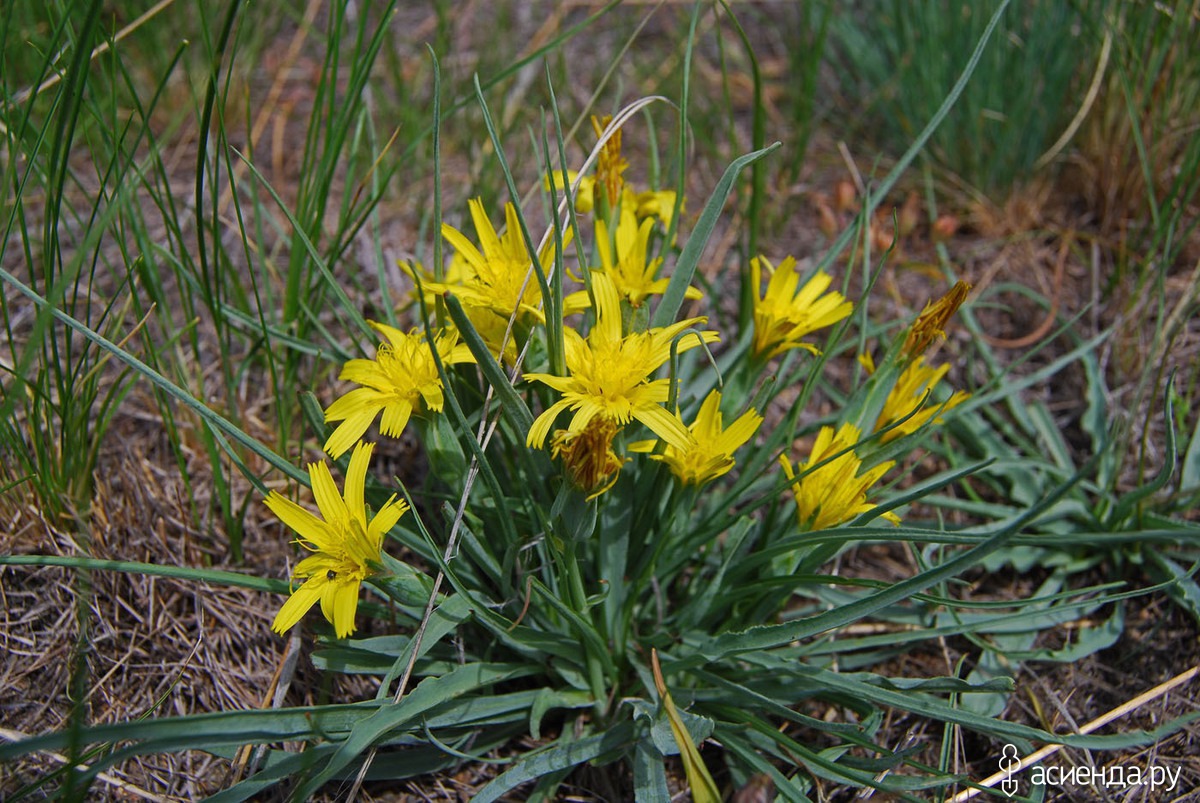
[436, 198, 571, 323]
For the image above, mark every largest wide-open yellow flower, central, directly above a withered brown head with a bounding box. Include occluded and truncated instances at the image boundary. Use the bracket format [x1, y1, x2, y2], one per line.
[524, 274, 718, 449]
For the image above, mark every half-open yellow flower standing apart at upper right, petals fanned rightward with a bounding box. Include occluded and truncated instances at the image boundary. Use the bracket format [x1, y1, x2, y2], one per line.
[750, 257, 854, 359]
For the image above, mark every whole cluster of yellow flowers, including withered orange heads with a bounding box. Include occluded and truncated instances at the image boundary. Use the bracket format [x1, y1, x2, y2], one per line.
[266, 114, 968, 652]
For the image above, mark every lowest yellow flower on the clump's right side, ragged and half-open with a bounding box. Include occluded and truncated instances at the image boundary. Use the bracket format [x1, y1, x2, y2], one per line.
[779, 424, 900, 529]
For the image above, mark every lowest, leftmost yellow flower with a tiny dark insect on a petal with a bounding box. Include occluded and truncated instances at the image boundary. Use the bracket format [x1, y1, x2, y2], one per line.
[265, 442, 408, 639]
